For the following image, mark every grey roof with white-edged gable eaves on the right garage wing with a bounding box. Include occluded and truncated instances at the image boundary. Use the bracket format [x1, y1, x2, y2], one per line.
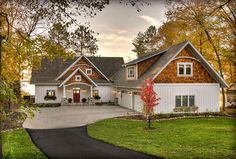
[114, 41, 228, 88]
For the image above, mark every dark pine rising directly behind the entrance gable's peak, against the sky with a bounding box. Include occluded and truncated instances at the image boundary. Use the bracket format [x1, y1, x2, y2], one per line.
[72, 25, 98, 55]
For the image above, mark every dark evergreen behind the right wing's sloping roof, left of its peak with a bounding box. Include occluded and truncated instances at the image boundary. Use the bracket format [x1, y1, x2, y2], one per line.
[132, 25, 157, 57]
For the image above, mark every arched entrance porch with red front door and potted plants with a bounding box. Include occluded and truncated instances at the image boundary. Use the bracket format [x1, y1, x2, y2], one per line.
[62, 82, 93, 104]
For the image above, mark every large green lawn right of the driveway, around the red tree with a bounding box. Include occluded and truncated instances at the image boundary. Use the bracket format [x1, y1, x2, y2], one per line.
[88, 118, 236, 159]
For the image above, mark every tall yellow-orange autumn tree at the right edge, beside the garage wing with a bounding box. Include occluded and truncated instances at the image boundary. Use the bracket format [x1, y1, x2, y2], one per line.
[167, 0, 236, 111]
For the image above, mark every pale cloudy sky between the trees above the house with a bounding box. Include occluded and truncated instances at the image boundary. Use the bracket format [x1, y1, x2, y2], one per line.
[77, 0, 166, 62]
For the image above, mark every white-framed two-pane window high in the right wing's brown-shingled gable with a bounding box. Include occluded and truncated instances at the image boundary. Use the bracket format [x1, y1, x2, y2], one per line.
[177, 62, 193, 77]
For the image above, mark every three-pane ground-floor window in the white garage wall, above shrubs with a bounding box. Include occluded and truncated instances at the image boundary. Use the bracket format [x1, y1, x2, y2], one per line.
[175, 95, 195, 107]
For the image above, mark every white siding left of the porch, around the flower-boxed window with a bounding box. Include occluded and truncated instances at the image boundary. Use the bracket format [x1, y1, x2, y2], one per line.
[35, 85, 62, 103]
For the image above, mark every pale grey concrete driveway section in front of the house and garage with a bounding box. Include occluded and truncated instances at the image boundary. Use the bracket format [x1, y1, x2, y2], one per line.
[23, 106, 137, 129]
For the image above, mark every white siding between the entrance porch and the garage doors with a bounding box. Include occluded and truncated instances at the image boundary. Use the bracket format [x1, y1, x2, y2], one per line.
[94, 86, 114, 102]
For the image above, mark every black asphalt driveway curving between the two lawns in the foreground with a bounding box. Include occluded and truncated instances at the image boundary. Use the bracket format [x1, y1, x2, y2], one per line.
[27, 126, 159, 159]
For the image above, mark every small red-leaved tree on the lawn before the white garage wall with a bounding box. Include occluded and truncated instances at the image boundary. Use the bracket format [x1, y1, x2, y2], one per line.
[141, 78, 160, 129]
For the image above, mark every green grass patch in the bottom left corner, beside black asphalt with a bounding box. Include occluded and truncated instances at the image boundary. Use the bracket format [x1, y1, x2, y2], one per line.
[2, 129, 47, 159]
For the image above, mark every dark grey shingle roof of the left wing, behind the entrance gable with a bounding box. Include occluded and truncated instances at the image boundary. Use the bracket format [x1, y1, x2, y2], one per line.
[31, 57, 124, 85]
